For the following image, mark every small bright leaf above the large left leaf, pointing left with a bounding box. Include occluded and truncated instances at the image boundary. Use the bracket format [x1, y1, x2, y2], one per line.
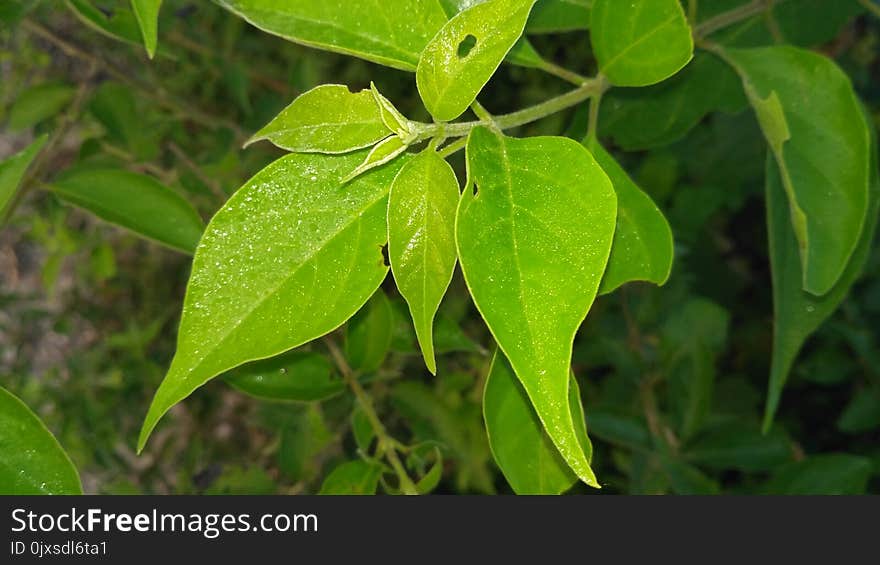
[245, 84, 391, 153]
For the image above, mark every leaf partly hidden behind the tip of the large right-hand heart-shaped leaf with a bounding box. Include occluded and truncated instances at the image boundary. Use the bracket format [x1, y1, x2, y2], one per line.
[483, 351, 593, 494]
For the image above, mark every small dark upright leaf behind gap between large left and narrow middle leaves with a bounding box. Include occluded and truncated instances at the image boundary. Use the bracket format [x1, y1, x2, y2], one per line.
[345, 290, 394, 373]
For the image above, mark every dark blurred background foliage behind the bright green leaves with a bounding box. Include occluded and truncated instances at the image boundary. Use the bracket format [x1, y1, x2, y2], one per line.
[0, 0, 880, 494]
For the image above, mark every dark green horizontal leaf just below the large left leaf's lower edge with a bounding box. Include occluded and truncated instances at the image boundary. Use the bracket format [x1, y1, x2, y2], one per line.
[223, 351, 345, 402]
